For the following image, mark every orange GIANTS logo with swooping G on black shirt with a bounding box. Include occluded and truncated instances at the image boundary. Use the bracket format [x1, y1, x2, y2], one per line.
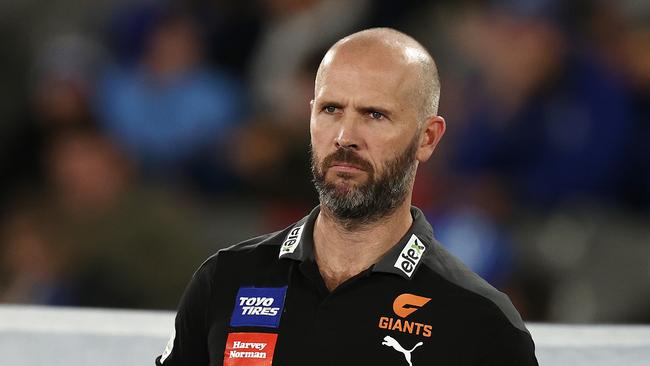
[379, 294, 432, 337]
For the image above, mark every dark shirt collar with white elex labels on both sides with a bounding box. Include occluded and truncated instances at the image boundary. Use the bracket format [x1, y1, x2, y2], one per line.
[279, 206, 433, 279]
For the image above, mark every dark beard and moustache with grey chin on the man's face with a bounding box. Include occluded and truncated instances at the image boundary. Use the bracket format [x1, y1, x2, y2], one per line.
[311, 135, 418, 230]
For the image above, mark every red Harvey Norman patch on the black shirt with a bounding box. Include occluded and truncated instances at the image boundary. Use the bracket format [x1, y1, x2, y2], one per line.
[223, 333, 278, 366]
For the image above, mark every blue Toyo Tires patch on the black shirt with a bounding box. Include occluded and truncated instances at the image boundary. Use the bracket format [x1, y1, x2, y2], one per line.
[230, 286, 287, 328]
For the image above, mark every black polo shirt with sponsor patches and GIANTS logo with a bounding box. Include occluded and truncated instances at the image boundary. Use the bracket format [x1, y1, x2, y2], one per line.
[156, 207, 537, 366]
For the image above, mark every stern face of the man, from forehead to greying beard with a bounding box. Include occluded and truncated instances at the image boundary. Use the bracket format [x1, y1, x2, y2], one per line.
[310, 44, 420, 222]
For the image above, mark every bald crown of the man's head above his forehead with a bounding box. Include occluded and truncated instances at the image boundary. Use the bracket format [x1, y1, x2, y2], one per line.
[315, 28, 440, 122]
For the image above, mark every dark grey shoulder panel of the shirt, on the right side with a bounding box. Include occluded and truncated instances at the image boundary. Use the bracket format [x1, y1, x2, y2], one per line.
[422, 240, 528, 333]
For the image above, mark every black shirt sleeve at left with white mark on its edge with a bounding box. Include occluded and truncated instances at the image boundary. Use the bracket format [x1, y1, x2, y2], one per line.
[156, 264, 211, 366]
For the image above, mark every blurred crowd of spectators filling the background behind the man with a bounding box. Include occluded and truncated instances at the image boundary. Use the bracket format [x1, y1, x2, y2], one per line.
[0, 0, 650, 322]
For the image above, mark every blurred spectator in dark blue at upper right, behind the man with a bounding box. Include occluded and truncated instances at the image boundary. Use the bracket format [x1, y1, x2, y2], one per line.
[442, 5, 632, 209]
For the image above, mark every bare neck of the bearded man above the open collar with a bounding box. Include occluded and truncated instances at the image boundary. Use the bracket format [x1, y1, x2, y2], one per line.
[314, 200, 413, 291]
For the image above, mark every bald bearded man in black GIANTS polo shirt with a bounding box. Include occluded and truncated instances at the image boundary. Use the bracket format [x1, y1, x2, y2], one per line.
[157, 29, 537, 366]
